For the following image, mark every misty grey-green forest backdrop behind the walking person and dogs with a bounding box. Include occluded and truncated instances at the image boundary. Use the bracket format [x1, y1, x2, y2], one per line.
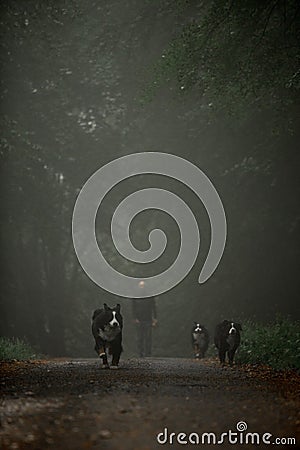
[0, 0, 300, 357]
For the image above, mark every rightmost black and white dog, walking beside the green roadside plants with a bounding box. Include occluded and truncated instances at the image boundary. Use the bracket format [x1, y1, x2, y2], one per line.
[214, 320, 242, 366]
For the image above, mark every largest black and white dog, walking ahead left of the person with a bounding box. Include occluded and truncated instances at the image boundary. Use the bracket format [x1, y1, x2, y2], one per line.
[92, 303, 123, 368]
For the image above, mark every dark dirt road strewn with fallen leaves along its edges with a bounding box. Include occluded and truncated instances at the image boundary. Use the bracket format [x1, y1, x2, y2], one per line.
[0, 358, 300, 450]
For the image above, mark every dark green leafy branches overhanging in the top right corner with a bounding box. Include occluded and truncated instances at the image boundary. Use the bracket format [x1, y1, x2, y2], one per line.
[144, 0, 300, 122]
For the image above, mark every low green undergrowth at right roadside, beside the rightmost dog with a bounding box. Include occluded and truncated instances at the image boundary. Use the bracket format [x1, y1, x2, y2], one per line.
[236, 318, 300, 369]
